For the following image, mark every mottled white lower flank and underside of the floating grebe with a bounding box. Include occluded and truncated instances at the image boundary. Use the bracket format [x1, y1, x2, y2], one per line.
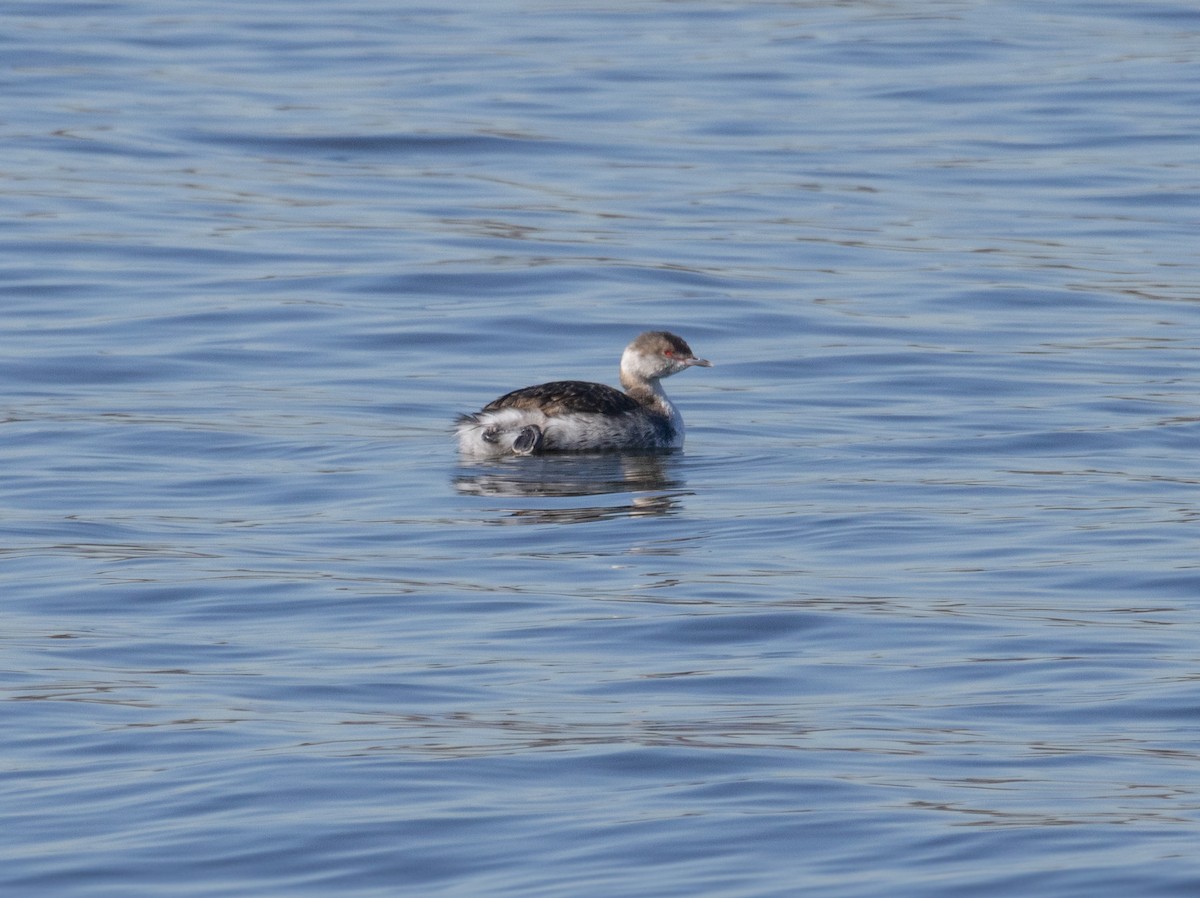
[457, 403, 683, 457]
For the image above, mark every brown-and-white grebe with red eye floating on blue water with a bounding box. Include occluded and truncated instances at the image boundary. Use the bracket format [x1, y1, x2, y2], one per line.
[456, 330, 712, 456]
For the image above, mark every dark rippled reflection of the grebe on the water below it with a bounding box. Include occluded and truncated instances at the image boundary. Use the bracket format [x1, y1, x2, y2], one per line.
[455, 453, 683, 523]
